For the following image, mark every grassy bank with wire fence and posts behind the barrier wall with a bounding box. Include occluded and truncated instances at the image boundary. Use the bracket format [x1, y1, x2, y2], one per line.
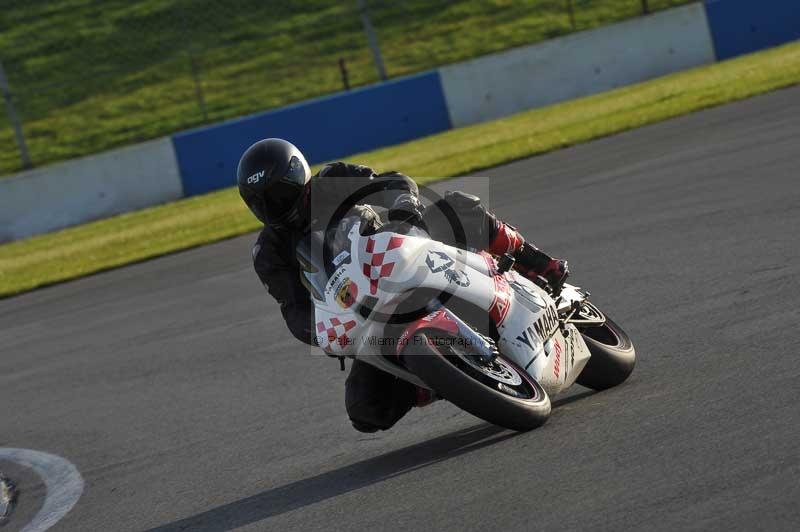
[0, 0, 692, 173]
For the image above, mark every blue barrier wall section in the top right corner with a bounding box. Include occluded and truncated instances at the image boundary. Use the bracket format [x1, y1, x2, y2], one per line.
[706, 0, 800, 61]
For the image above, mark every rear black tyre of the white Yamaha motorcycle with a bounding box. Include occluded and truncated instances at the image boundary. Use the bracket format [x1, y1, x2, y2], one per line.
[575, 317, 636, 390]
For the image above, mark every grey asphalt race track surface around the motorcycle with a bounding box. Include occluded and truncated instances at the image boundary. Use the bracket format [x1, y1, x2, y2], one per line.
[0, 88, 800, 532]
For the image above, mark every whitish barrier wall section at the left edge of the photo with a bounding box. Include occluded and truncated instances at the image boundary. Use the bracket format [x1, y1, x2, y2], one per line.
[0, 138, 183, 242]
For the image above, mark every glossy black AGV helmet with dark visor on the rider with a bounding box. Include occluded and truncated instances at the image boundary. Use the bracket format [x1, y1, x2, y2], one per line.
[236, 139, 311, 227]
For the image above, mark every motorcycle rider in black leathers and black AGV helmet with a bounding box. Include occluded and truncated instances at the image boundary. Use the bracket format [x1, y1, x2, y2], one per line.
[237, 138, 568, 432]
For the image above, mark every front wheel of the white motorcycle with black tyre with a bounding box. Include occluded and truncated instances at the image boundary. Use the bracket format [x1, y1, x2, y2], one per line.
[403, 331, 550, 431]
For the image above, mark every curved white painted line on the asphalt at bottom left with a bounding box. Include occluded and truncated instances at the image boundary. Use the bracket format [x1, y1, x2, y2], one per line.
[0, 447, 83, 532]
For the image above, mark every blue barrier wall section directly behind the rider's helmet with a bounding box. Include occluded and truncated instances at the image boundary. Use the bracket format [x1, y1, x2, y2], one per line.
[172, 71, 450, 196]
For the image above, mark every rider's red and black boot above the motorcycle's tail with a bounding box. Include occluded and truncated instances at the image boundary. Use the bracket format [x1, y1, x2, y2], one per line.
[487, 220, 569, 295]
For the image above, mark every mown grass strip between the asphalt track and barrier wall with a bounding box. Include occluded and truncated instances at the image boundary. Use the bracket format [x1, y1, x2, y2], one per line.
[0, 42, 800, 296]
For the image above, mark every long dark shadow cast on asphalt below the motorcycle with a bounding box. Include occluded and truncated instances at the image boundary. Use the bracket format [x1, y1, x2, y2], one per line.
[147, 424, 519, 532]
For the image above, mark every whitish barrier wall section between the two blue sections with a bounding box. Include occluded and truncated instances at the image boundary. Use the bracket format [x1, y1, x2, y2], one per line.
[441, 4, 714, 127]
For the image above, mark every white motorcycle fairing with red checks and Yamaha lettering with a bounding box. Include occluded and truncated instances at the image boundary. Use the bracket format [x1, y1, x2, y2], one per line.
[315, 219, 590, 395]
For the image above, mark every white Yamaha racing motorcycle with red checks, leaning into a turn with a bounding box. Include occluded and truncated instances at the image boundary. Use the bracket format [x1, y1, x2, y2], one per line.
[297, 216, 636, 431]
